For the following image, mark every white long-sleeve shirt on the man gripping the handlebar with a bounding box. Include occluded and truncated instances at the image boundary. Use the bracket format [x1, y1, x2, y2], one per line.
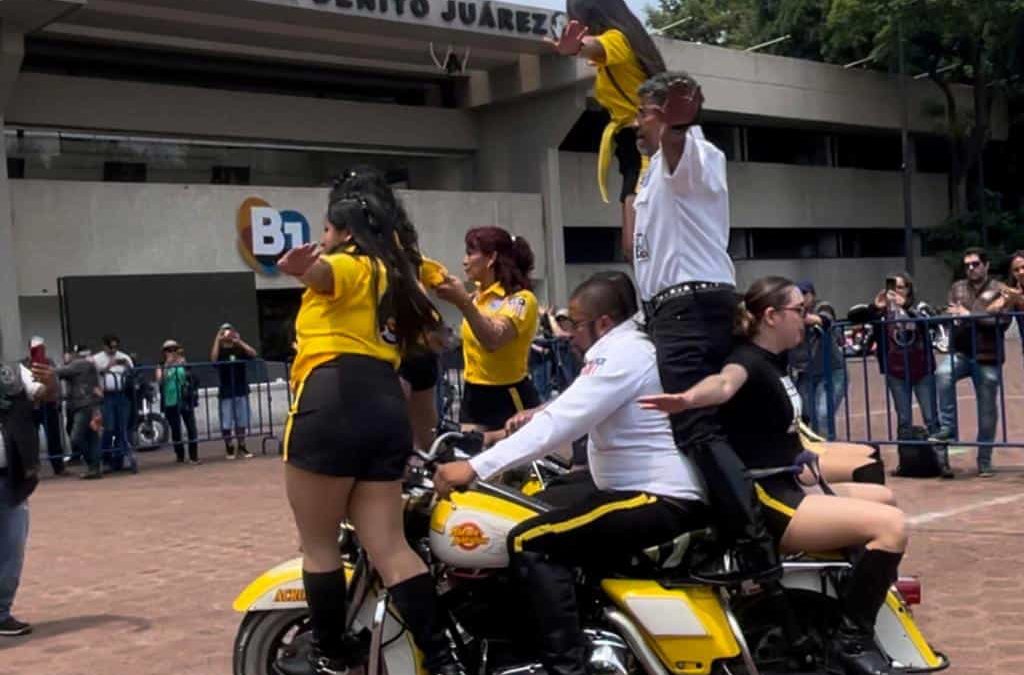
[470, 321, 705, 501]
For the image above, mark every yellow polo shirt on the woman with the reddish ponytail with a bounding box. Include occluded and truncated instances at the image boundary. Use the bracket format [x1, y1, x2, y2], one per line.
[462, 283, 539, 386]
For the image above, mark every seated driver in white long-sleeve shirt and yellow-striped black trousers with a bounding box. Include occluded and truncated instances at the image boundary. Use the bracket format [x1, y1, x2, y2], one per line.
[434, 275, 707, 675]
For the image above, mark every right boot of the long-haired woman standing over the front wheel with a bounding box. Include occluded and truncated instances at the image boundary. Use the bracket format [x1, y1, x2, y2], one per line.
[388, 573, 464, 675]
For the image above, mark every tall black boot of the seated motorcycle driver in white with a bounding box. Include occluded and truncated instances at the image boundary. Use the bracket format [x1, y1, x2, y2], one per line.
[511, 552, 587, 675]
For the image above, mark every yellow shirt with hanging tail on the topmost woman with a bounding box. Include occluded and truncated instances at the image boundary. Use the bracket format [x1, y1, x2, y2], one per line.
[591, 29, 647, 202]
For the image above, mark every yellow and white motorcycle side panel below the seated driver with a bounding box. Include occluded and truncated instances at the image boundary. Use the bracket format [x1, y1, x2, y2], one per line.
[601, 579, 739, 675]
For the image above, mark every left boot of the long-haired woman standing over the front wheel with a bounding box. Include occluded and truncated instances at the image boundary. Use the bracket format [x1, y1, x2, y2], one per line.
[274, 569, 348, 675]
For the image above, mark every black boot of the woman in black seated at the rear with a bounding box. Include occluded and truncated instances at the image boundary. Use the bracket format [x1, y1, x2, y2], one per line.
[833, 549, 903, 675]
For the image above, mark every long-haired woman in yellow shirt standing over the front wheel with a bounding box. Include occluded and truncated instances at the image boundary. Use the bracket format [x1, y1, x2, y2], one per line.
[275, 188, 461, 675]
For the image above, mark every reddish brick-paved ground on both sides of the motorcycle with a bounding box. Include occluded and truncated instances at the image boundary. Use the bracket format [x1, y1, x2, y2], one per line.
[6, 350, 1024, 675]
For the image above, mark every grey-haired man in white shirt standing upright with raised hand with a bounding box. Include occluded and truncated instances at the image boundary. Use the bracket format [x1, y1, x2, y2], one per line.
[624, 73, 779, 574]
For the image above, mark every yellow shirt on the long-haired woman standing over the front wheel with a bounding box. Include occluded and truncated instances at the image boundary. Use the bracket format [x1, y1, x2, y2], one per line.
[291, 252, 400, 391]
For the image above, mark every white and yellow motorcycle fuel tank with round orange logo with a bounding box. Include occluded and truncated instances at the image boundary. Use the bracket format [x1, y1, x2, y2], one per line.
[430, 491, 537, 569]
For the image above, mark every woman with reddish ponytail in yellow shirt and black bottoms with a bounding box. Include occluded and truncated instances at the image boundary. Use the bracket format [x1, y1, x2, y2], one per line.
[434, 227, 540, 431]
